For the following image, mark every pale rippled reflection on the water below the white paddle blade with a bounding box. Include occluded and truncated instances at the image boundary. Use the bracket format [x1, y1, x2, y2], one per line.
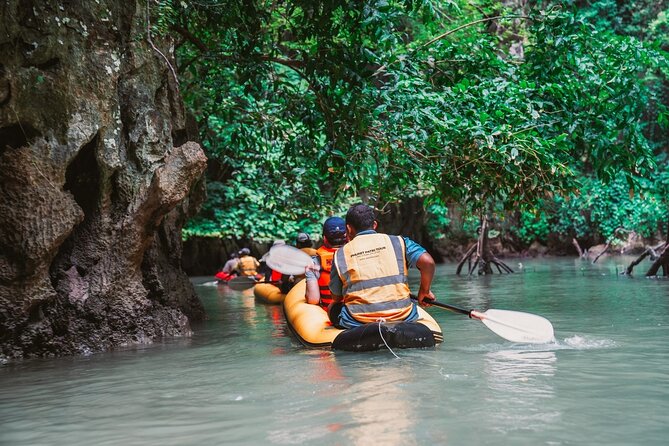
[484, 350, 561, 432]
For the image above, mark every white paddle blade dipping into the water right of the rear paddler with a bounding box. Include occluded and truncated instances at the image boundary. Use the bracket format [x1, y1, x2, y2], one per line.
[472, 310, 555, 344]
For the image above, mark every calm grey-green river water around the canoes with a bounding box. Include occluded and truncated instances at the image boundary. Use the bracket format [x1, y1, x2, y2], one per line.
[0, 258, 669, 446]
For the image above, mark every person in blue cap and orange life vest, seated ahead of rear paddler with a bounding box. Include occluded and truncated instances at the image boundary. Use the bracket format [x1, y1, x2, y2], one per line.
[305, 217, 346, 310]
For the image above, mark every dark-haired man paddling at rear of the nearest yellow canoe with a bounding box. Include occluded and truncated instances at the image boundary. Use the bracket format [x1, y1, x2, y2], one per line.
[328, 203, 435, 328]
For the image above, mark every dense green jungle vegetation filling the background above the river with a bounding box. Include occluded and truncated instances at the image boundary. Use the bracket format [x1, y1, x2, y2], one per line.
[159, 0, 669, 251]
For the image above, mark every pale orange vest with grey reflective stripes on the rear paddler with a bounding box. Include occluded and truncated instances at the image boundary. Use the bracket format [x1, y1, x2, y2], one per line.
[334, 234, 412, 323]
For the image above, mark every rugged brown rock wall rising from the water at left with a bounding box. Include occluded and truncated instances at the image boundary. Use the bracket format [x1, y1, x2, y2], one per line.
[0, 0, 206, 360]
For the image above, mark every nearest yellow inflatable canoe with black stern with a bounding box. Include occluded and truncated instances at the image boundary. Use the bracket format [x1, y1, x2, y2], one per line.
[282, 280, 443, 351]
